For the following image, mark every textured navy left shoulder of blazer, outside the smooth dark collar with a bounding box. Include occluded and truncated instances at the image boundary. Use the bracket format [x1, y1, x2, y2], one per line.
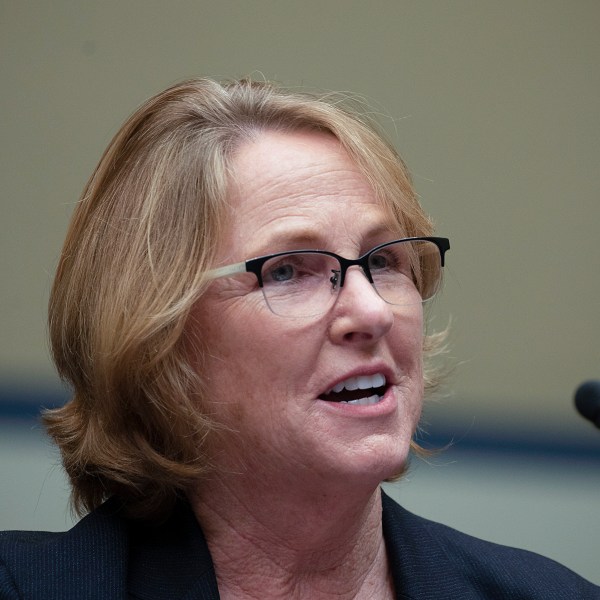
[0, 496, 127, 600]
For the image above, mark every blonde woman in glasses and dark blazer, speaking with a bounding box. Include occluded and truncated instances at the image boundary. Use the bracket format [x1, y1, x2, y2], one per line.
[0, 80, 600, 600]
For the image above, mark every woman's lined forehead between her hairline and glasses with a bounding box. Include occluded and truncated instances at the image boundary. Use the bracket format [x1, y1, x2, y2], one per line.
[226, 132, 391, 259]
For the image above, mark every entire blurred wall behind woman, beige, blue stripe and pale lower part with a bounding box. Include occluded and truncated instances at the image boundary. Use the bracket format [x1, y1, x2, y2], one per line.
[0, 0, 600, 583]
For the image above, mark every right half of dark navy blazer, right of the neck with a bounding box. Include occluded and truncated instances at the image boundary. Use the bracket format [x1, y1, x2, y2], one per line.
[383, 495, 600, 600]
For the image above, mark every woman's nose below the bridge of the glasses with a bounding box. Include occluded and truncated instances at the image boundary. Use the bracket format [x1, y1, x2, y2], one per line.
[329, 266, 394, 344]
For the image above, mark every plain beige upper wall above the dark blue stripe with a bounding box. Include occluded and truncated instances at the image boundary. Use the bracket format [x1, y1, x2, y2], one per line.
[0, 0, 600, 435]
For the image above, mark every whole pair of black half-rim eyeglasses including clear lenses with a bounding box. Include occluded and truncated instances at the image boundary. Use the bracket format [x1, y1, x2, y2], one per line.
[206, 237, 450, 317]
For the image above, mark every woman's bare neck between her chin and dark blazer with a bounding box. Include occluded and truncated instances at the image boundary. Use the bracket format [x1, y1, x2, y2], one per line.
[190, 475, 392, 600]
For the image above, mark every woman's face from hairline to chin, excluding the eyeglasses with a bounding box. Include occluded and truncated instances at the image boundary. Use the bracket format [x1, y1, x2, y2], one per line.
[190, 132, 423, 492]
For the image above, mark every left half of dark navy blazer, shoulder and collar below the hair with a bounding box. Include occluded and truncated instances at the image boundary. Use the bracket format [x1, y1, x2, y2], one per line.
[0, 500, 219, 600]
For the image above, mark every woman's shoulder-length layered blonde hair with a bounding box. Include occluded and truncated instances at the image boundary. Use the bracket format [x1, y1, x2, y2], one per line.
[44, 79, 437, 519]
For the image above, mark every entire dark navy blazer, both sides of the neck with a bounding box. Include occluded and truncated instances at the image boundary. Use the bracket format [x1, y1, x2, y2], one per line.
[0, 495, 600, 600]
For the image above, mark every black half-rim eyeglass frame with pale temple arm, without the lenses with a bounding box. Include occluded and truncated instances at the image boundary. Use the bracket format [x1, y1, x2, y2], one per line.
[206, 237, 450, 298]
